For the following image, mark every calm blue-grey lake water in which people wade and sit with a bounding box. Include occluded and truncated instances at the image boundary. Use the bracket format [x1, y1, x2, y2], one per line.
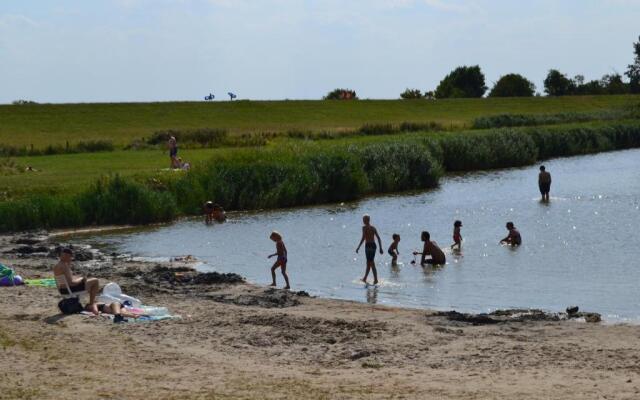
[90, 150, 640, 321]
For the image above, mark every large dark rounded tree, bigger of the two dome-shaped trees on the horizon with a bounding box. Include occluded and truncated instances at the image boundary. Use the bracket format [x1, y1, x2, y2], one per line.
[435, 65, 487, 99]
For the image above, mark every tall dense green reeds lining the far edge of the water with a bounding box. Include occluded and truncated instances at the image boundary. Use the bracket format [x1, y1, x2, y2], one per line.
[0, 121, 640, 231]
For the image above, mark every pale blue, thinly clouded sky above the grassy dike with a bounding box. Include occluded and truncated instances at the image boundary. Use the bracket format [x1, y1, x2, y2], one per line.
[0, 0, 640, 103]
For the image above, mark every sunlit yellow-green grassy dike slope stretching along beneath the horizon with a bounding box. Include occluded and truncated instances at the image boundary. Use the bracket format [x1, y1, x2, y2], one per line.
[0, 96, 640, 148]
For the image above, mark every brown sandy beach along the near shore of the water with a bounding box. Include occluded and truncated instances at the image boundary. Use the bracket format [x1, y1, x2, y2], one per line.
[0, 236, 640, 399]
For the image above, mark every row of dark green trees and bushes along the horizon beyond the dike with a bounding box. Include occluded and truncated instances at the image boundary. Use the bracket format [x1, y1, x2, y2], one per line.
[324, 37, 640, 100]
